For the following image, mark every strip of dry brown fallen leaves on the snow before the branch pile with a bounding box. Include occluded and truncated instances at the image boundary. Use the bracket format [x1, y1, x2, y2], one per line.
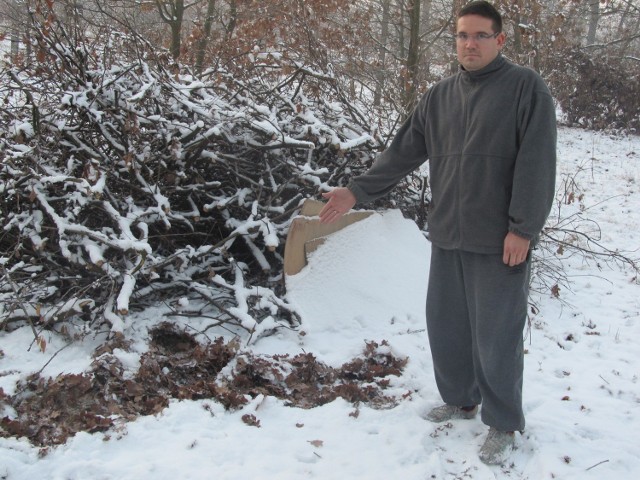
[0, 323, 407, 447]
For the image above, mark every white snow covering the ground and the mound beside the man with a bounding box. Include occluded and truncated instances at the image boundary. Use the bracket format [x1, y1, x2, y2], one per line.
[0, 128, 640, 480]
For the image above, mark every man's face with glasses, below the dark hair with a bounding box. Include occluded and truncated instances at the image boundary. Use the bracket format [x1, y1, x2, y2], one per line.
[456, 15, 506, 71]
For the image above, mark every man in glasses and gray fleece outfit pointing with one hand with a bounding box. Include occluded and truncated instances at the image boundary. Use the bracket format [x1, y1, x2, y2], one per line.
[320, 1, 556, 464]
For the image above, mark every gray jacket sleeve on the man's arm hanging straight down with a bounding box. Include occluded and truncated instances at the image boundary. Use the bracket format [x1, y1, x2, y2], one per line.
[509, 77, 557, 243]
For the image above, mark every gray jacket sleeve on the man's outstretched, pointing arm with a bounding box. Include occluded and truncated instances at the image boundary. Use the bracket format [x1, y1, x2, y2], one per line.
[347, 93, 428, 203]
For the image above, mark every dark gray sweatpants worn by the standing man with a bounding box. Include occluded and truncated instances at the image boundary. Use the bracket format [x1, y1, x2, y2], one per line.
[427, 245, 531, 431]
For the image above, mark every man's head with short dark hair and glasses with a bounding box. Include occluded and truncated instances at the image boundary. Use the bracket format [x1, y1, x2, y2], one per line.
[456, 1, 506, 71]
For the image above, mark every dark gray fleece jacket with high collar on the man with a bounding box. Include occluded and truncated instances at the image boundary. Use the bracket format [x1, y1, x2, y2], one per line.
[348, 54, 556, 254]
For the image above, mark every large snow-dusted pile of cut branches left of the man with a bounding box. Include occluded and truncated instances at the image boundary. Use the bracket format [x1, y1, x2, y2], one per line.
[0, 5, 390, 338]
